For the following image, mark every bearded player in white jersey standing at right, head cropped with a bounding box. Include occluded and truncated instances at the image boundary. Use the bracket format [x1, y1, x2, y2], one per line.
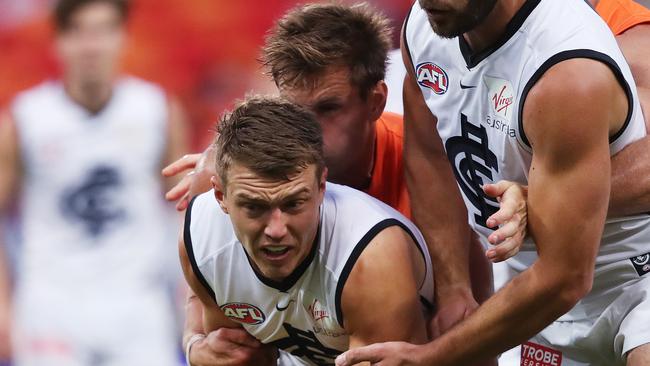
[337, 0, 650, 366]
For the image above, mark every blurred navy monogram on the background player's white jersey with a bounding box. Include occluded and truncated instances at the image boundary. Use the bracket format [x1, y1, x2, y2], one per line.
[61, 166, 126, 237]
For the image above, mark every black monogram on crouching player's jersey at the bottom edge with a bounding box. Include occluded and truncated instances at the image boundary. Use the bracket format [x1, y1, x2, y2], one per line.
[272, 323, 341, 366]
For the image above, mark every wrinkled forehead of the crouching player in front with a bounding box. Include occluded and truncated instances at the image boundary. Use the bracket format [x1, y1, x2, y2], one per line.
[227, 164, 317, 202]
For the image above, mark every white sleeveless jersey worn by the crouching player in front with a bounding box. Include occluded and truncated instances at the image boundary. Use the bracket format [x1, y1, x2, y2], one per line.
[185, 183, 433, 365]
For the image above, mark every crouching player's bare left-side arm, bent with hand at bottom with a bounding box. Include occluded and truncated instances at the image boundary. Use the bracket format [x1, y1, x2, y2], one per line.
[178, 234, 277, 366]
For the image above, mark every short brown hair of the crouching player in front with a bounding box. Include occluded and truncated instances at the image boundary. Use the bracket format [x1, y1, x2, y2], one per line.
[214, 96, 325, 185]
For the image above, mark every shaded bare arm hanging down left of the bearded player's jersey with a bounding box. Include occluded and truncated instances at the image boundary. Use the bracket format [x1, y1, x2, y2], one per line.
[402, 35, 477, 331]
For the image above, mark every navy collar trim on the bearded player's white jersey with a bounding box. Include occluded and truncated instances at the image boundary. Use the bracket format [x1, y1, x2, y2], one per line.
[458, 0, 541, 69]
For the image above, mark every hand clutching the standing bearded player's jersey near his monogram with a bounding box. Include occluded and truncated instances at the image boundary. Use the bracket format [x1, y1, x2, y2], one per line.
[483, 180, 528, 263]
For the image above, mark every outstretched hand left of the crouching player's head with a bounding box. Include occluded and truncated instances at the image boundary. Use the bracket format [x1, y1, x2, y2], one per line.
[162, 147, 216, 211]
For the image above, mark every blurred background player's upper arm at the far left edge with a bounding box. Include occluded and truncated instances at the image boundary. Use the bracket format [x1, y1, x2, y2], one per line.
[0, 111, 21, 212]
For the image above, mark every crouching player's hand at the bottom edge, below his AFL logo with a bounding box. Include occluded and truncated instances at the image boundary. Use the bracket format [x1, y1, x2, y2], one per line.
[190, 328, 278, 366]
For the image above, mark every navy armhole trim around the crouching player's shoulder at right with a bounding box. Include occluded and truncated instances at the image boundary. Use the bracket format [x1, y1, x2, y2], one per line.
[334, 219, 427, 328]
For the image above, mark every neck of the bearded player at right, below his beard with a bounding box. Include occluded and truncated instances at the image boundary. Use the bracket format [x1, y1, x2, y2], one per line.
[462, 0, 526, 53]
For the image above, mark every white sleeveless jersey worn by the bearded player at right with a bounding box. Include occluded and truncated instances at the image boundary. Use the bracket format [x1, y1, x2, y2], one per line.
[405, 0, 650, 272]
